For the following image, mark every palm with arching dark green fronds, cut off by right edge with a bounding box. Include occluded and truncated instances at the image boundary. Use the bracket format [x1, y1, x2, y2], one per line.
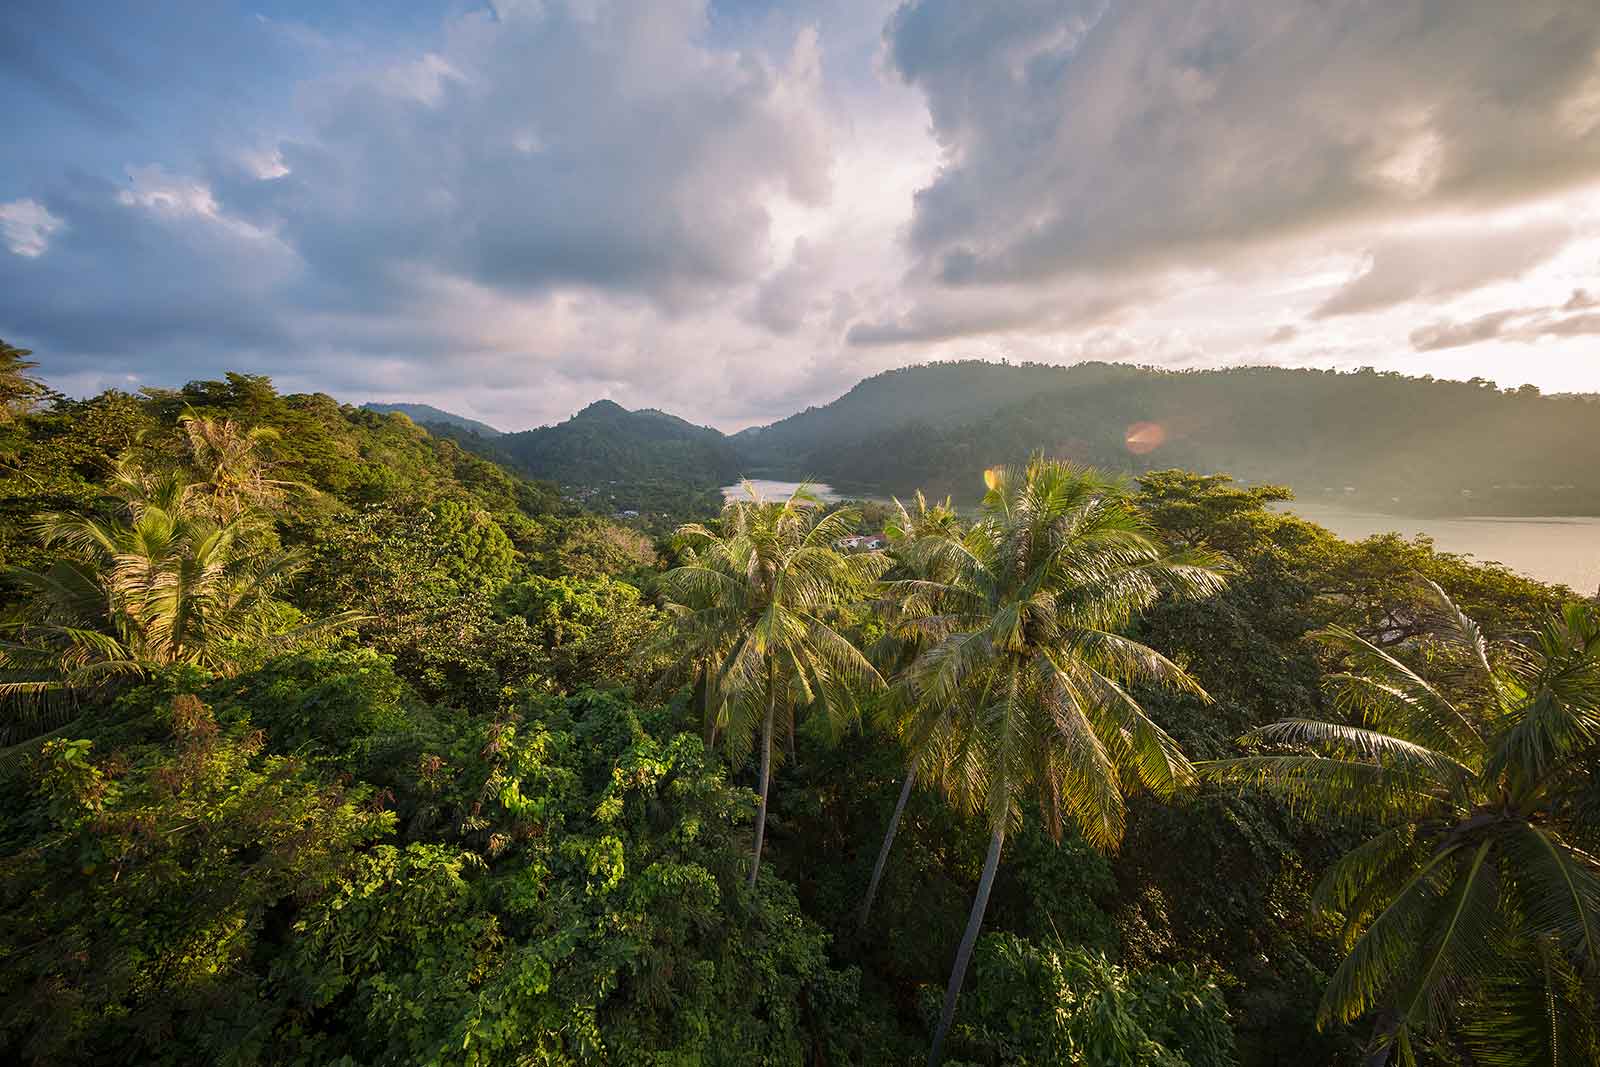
[1202, 582, 1600, 1064]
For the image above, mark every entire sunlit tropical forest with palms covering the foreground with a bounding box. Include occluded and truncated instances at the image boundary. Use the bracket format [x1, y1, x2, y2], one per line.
[0, 346, 1600, 1067]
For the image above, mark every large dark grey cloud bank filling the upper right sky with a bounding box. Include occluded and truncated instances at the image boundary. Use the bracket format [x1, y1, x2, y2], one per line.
[885, 0, 1600, 286]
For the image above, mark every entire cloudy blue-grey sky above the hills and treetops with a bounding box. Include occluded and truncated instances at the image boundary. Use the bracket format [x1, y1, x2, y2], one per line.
[0, 0, 1600, 430]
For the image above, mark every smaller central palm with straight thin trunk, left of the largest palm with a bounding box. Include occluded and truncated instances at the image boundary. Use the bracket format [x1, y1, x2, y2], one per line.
[659, 482, 888, 886]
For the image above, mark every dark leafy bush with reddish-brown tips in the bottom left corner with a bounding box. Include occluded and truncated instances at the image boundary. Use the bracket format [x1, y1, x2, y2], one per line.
[0, 696, 392, 1062]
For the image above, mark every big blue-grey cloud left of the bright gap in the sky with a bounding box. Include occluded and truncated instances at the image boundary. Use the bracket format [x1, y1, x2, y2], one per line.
[235, 0, 830, 313]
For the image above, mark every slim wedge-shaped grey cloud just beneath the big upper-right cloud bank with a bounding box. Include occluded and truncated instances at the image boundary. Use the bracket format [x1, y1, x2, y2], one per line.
[1312, 221, 1573, 318]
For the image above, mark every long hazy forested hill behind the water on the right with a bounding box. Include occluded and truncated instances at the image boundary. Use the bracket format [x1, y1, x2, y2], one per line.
[748, 363, 1600, 514]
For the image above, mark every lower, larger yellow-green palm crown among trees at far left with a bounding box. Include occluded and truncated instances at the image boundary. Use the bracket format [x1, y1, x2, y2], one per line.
[0, 461, 352, 741]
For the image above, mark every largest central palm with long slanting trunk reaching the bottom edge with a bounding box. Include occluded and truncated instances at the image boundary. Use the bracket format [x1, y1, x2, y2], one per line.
[891, 458, 1222, 1064]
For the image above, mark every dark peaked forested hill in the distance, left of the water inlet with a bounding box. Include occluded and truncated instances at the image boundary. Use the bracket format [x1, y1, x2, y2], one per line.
[494, 400, 741, 486]
